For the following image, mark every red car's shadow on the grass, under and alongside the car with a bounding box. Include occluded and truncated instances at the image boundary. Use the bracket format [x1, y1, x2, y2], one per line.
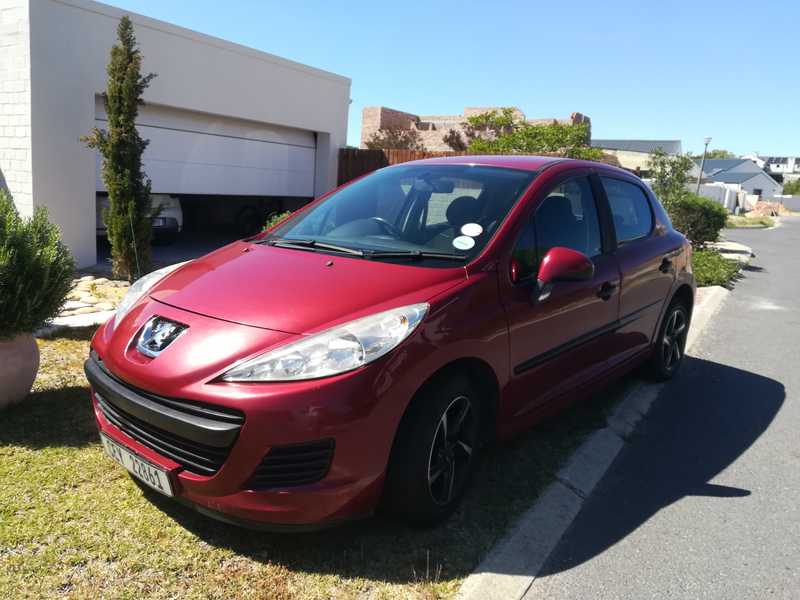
[140, 378, 636, 583]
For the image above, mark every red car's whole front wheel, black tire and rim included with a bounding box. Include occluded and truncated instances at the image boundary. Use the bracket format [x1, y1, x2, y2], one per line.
[381, 374, 480, 526]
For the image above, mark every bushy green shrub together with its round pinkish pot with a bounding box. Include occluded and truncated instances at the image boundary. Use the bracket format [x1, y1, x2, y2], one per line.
[0, 190, 75, 410]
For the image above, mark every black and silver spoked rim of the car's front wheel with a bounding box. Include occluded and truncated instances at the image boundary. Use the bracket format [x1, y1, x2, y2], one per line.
[428, 396, 475, 506]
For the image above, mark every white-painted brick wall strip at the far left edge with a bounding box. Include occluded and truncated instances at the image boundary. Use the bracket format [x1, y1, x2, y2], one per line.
[0, 0, 33, 217]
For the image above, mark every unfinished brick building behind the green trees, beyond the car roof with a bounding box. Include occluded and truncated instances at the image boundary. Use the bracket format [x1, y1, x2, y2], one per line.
[361, 106, 591, 151]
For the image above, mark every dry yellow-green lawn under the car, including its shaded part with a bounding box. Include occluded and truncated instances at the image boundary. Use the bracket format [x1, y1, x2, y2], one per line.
[0, 328, 630, 600]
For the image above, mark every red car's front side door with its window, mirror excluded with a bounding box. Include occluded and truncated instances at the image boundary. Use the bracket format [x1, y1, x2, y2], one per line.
[498, 171, 619, 423]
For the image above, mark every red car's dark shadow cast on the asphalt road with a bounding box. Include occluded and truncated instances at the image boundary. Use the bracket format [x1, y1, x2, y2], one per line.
[539, 357, 786, 577]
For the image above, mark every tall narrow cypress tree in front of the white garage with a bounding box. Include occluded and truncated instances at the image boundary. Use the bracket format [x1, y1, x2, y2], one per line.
[78, 15, 156, 281]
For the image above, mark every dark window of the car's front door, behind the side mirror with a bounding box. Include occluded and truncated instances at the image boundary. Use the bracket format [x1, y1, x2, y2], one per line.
[512, 177, 603, 281]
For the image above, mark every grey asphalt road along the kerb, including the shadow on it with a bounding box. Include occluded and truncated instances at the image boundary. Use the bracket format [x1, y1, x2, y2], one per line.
[525, 216, 800, 600]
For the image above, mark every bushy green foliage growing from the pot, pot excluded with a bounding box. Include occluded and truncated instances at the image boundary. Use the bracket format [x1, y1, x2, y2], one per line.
[0, 190, 75, 341]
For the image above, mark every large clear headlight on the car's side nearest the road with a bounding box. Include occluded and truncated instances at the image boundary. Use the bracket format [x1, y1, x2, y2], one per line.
[222, 303, 429, 382]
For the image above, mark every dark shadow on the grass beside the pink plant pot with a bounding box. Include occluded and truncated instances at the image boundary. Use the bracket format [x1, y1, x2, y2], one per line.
[0, 386, 98, 449]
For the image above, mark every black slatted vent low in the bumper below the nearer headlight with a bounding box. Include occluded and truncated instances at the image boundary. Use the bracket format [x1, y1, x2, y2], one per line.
[245, 438, 335, 489]
